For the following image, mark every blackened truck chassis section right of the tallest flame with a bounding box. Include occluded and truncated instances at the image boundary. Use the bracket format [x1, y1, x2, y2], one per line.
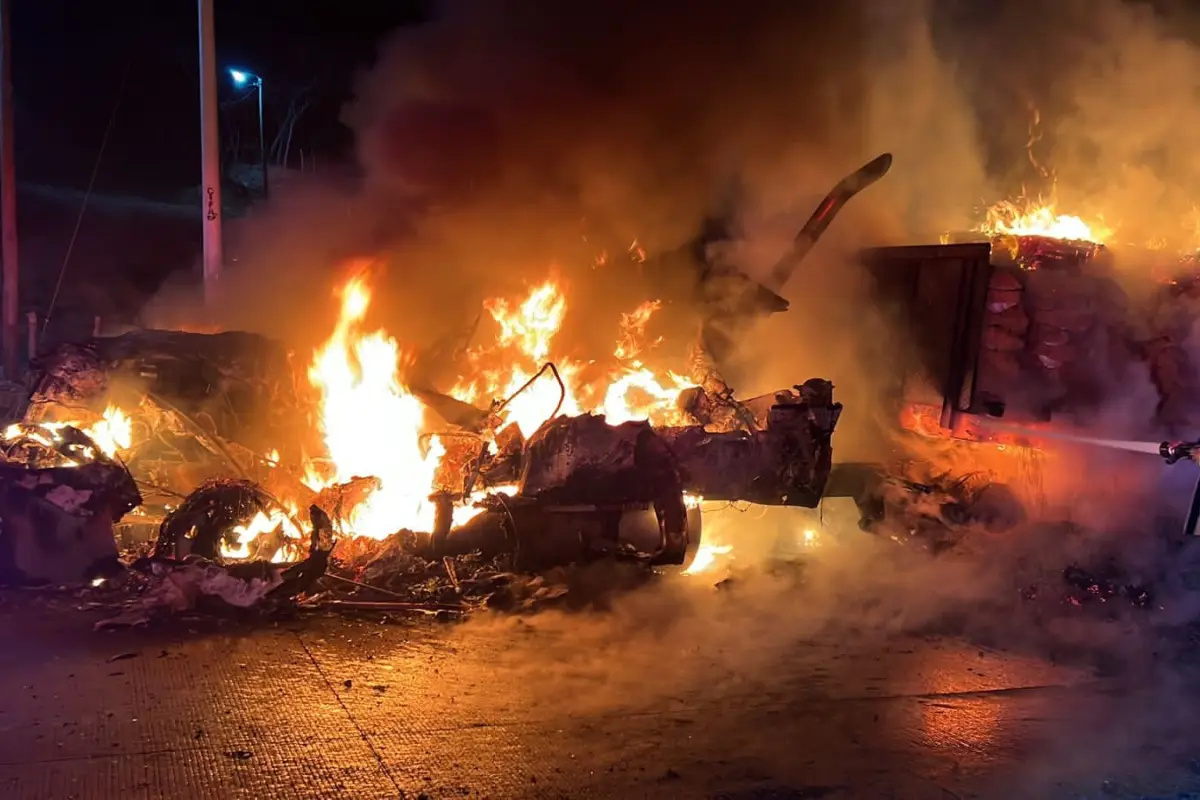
[431, 380, 841, 565]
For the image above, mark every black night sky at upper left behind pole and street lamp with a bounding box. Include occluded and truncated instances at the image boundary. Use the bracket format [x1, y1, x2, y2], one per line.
[11, 0, 430, 199]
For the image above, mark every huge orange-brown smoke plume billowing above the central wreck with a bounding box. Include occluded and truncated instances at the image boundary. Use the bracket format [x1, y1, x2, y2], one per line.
[147, 0, 985, 379]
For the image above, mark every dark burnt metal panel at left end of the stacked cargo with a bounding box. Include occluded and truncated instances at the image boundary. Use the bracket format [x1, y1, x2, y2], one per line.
[863, 242, 991, 429]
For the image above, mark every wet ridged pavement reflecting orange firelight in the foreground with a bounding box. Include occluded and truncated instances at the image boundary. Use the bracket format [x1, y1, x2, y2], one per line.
[0, 582, 1200, 800]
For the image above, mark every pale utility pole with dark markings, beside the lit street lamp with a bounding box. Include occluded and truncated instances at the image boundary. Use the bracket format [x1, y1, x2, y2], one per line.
[196, 0, 224, 305]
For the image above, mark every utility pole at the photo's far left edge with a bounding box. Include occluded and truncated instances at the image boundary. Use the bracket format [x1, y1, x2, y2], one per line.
[0, 0, 20, 380]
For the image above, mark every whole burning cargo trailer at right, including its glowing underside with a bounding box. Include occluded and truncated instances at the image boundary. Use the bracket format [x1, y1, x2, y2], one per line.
[849, 191, 1200, 563]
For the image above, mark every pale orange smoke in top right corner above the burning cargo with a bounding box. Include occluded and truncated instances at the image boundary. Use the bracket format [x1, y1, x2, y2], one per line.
[944, 0, 1200, 249]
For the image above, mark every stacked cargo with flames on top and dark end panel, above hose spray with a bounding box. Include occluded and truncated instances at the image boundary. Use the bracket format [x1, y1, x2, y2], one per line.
[883, 196, 1200, 440]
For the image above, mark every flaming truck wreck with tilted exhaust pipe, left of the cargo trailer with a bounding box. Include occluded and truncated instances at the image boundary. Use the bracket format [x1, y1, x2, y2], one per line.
[0, 156, 890, 606]
